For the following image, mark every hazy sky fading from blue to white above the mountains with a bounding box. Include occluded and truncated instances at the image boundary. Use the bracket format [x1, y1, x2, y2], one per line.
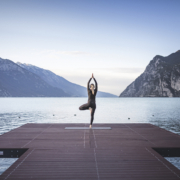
[0, 0, 180, 95]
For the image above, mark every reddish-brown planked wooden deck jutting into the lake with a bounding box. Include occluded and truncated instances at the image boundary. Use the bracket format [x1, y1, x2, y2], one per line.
[0, 124, 180, 180]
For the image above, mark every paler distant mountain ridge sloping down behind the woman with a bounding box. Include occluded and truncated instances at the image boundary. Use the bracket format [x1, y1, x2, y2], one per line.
[17, 62, 117, 97]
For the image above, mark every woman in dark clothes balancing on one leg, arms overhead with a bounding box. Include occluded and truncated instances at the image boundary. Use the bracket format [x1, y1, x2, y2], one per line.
[79, 74, 98, 128]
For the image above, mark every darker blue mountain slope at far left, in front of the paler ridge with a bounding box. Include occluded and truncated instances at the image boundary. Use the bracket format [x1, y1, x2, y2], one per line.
[0, 58, 70, 97]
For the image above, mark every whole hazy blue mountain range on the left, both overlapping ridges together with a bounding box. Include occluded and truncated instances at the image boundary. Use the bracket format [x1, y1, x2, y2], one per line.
[0, 58, 117, 97]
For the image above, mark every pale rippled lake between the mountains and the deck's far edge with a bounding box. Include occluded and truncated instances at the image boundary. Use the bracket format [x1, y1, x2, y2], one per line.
[0, 98, 180, 134]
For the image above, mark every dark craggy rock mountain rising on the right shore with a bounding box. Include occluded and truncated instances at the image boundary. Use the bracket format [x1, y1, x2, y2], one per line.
[120, 50, 180, 97]
